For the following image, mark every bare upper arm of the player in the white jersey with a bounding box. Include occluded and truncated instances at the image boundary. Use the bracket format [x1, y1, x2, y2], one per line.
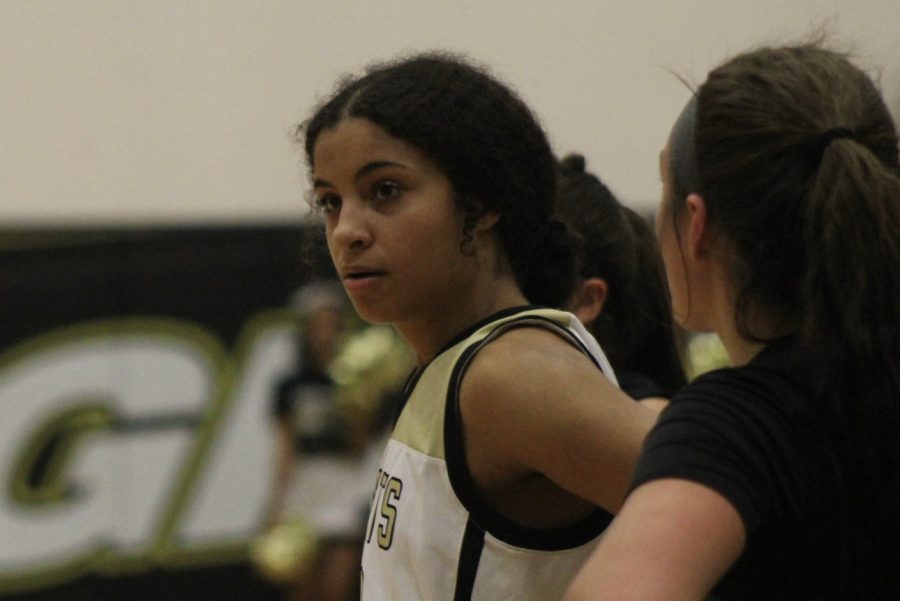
[460, 328, 656, 512]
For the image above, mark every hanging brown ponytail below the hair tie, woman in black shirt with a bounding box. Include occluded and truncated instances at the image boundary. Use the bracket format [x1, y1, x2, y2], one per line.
[802, 129, 900, 598]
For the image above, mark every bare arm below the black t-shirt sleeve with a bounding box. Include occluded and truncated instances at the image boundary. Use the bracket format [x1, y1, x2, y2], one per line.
[566, 479, 745, 601]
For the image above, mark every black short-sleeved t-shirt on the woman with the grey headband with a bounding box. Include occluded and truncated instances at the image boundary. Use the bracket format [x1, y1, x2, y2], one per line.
[632, 339, 836, 601]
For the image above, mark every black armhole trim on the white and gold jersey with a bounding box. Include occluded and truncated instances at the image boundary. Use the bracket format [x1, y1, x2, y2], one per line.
[444, 315, 612, 551]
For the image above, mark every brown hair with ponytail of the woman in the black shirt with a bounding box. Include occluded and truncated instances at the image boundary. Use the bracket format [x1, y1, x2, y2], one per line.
[688, 44, 900, 599]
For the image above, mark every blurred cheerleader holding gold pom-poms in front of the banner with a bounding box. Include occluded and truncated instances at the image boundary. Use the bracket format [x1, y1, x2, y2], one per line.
[263, 281, 371, 601]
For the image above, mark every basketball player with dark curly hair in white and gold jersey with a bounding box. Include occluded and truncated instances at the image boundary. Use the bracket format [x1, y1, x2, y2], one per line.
[298, 54, 655, 601]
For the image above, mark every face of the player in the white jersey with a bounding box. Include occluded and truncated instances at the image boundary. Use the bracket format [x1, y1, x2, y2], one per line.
[313, 118, 475, 324]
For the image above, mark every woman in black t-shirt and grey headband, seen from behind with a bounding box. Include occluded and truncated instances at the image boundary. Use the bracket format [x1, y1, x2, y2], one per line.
[567, 43, 900, 601]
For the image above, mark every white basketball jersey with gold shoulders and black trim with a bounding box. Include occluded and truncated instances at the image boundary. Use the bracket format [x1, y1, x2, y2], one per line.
[362, 308, 615, 601]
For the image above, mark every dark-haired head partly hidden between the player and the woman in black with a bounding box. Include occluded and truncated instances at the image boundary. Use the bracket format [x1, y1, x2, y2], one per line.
[556, 154, 686, 410]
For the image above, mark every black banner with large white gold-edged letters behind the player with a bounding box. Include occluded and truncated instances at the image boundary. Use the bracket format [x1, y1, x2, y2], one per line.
[0, 225, 322, 601]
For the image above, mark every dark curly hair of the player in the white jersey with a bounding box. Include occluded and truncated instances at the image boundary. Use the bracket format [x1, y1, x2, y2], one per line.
[296, 52, 575, 307]
